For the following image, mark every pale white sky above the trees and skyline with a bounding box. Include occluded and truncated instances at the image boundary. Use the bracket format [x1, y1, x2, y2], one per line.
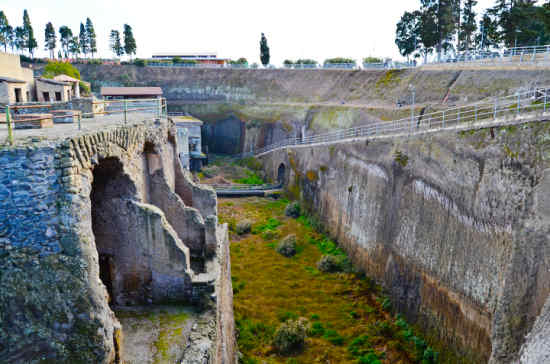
[0, 0, 504, 65]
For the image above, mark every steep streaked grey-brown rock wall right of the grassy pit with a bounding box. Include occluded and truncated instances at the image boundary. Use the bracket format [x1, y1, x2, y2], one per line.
[261, 123, 550, 363]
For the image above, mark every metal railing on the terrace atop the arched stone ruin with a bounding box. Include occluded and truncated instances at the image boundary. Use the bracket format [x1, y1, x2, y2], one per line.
[0, 98, 167, 145]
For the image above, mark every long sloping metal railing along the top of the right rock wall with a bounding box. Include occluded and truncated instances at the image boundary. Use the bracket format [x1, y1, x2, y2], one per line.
[249, 86, 550, 157]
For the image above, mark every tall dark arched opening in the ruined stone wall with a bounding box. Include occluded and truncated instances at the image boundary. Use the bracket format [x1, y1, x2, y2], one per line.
[90, 158, 136, 304]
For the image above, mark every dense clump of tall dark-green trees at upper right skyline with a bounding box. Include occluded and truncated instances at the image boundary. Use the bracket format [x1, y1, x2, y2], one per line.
[395, 0, 550, 61]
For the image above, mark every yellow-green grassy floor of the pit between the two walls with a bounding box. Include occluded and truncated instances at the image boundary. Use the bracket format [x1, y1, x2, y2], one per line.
[219, 197, 472, 364]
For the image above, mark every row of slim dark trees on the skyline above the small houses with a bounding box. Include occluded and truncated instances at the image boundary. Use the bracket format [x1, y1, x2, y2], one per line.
[0, 10, 137, 59]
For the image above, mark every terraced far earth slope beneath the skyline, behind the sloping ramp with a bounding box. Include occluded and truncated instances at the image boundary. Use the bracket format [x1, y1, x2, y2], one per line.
[78, 65, 550, 154]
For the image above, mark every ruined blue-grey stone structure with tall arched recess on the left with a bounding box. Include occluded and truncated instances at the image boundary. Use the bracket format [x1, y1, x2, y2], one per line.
[0, 120, 235, 363]
